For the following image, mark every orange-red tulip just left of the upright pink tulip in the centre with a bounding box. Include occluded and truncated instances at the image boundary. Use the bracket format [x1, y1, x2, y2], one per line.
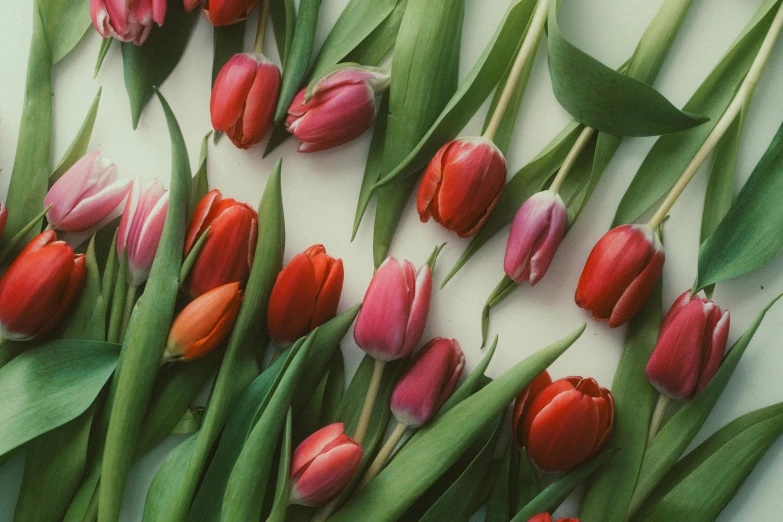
[267, 245, 343, 344]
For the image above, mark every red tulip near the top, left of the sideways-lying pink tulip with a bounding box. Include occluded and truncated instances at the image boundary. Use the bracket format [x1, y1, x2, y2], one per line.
[209, 53, 280, 149]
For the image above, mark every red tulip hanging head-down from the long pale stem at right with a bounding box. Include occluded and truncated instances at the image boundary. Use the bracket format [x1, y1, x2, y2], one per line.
[575, 225, 664, 328]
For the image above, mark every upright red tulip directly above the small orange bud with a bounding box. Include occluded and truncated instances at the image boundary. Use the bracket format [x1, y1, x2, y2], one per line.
[185, 189, 258, 298]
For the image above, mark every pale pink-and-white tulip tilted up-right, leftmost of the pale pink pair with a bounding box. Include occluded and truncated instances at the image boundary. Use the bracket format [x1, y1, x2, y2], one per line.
[44, 150, 130, 232]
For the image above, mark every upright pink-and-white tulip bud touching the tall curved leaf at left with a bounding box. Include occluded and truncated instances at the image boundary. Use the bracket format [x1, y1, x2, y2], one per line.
[117, 178, 169, 286]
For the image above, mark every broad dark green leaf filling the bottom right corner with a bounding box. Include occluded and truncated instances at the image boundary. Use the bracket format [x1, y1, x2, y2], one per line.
[634, 403, 783, 522]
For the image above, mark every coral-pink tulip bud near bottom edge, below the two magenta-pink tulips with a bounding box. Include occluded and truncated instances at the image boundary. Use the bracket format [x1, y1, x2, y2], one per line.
[290, 422, 364, 507]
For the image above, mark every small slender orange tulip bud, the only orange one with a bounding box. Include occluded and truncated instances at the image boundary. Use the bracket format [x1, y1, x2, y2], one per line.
[163, 282, 242, 361]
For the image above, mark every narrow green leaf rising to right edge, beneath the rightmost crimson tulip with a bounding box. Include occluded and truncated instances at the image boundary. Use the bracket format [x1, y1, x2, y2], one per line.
[627, 296, 780, 517]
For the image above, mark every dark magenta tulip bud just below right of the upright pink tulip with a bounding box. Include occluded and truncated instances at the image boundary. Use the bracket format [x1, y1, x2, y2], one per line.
[391, 337, 465, 428]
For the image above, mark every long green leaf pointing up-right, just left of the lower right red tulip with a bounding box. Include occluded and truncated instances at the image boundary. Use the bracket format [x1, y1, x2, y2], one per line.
[331, 326, 585, 522]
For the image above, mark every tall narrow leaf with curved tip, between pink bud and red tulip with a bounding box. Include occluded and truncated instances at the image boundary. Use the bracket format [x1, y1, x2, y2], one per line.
[98, 92, 191, 521]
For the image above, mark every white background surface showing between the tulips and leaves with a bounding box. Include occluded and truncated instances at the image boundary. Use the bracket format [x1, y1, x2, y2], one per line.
[0, 0, 783, 521]
